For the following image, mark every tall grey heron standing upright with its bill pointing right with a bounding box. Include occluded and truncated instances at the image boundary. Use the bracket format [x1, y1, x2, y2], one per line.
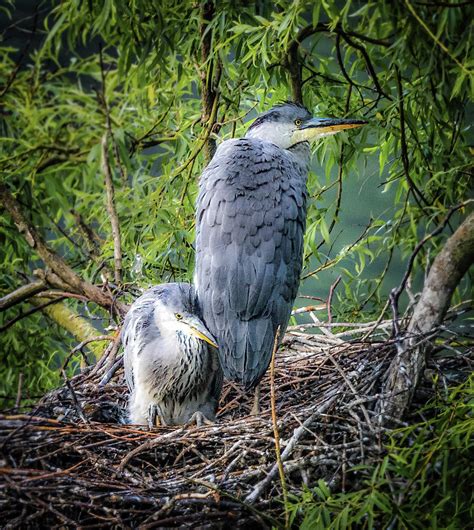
[194, 103, 366, 406]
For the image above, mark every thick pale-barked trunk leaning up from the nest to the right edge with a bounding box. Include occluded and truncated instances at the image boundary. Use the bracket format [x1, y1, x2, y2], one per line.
[379, 210, 474, 422]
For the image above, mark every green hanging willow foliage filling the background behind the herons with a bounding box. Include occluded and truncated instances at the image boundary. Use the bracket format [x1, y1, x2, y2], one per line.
[0, 0, 474, 396]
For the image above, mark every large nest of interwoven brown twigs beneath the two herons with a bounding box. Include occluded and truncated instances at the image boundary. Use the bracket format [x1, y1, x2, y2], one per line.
[0, 323, 470, 528]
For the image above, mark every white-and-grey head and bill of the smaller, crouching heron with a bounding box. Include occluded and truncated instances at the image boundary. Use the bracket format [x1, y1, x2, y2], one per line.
[153, 283, 217, 348]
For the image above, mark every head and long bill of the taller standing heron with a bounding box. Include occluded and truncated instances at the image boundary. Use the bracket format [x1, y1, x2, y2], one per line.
[245, 103, 367, 149]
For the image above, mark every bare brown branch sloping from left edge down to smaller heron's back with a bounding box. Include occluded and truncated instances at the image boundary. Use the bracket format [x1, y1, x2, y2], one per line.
[0, 183, 126, 314]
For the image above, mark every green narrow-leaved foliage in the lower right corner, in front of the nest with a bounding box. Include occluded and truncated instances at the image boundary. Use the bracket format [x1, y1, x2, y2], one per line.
[289, 377, 474, 530]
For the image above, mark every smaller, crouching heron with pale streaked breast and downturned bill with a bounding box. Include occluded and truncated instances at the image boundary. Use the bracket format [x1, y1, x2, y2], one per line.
[121, 283, 222, 427]
